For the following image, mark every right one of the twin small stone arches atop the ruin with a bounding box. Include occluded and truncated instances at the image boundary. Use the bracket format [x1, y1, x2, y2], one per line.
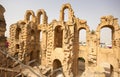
[37, 9, 48, 24]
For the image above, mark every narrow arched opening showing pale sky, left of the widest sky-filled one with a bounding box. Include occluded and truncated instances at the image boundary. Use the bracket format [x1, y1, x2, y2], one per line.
[79, 29, 86, 46]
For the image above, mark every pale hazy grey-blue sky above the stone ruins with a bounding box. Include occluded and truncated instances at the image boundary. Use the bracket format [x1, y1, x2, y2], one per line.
[0, 0, 120, 41]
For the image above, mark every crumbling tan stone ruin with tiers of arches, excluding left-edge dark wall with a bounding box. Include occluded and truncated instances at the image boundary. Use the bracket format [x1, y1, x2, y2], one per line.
[0, 3, 120, 77]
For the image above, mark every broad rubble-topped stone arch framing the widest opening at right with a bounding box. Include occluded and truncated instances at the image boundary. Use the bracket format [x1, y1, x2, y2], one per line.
[96, 15, 119, 46]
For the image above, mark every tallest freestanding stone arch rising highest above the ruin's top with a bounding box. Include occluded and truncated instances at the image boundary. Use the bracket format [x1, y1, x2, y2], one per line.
[60, 3, 74, 21]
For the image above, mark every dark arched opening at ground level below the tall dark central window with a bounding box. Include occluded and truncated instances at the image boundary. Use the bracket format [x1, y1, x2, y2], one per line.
[52, 59, 64, 77]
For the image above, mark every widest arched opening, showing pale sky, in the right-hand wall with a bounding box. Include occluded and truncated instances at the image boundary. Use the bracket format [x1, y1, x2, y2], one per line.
[100, 27, 113, 48]
